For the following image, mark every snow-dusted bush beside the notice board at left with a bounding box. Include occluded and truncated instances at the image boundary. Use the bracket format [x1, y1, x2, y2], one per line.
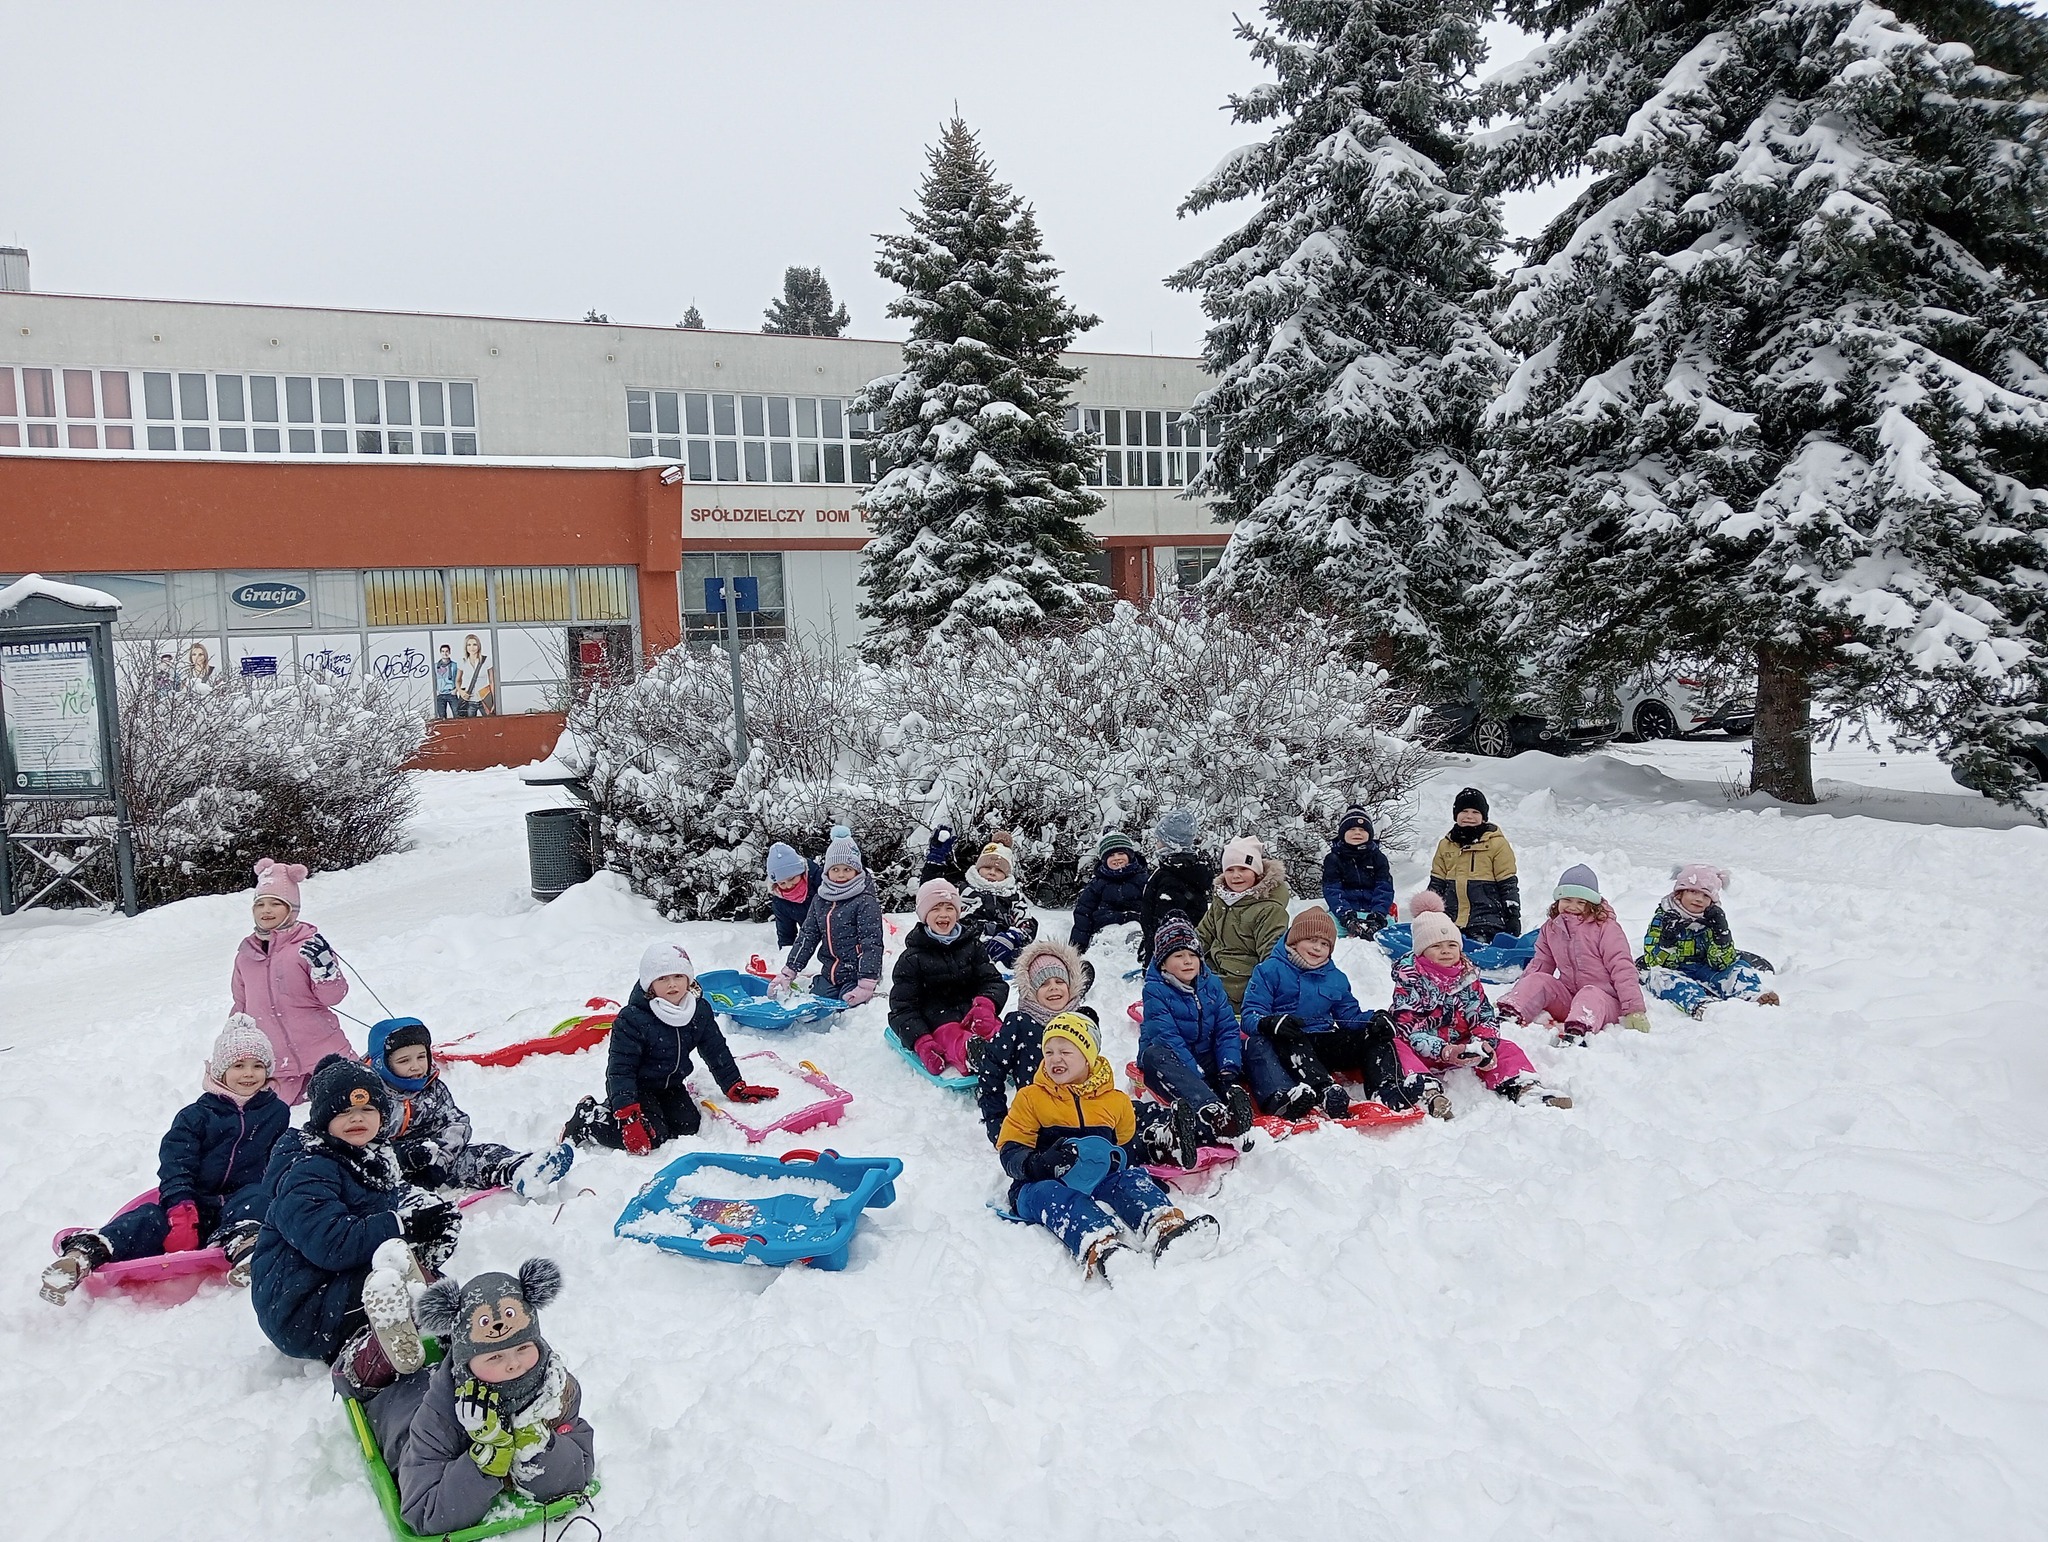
[119, 653, 426, 905]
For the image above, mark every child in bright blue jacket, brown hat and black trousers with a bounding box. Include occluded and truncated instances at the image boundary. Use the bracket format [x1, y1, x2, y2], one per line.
[1243, 909, 1407, 1118]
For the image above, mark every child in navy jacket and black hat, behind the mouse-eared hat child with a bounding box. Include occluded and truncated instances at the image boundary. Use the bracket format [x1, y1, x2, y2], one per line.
[250, 1055, 463, 1390]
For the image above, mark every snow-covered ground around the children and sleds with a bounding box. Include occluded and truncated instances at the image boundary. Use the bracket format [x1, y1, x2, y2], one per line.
[0, 743, 2048, 1542]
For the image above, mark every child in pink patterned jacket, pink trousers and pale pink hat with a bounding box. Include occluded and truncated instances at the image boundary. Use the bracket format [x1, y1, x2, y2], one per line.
[1391, 895, 1571, 1118]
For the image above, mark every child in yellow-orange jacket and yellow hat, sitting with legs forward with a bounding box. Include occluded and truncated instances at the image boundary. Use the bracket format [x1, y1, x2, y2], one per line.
[997, 1012, 1217, 1280]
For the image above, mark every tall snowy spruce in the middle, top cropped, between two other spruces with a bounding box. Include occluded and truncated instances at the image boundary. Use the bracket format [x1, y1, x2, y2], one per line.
[1167, 0, 1507, 672]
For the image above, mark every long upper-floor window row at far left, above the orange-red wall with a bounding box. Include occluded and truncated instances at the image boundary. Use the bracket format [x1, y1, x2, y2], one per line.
[0, 365, 477, 455]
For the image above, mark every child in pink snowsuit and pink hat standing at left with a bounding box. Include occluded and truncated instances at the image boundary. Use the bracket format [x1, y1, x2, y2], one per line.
[229, 856, 356, 1104]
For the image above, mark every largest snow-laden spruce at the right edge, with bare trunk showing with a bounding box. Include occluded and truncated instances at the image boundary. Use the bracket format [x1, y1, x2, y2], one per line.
[1489, 0, 2048, 803]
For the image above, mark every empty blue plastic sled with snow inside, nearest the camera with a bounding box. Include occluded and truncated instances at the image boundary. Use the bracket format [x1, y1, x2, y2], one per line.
[612, 1151, 903, 1270]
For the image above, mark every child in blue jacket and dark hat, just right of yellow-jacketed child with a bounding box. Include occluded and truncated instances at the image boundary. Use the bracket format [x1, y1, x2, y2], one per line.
[1139, 915, 1251, 1167]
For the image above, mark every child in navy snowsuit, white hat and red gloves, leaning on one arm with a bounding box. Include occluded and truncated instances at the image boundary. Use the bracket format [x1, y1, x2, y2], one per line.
[561, 938, 776, 1157]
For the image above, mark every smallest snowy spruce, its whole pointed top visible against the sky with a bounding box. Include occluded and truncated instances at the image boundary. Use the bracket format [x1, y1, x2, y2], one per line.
[854, 119, 1110, 659]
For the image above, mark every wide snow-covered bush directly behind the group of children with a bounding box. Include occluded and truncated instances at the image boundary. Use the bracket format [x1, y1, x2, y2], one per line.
[571, 596, 1427, 917]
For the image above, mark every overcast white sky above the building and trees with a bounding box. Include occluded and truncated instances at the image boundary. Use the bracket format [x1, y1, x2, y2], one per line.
[0, 0, 1554, 354]
